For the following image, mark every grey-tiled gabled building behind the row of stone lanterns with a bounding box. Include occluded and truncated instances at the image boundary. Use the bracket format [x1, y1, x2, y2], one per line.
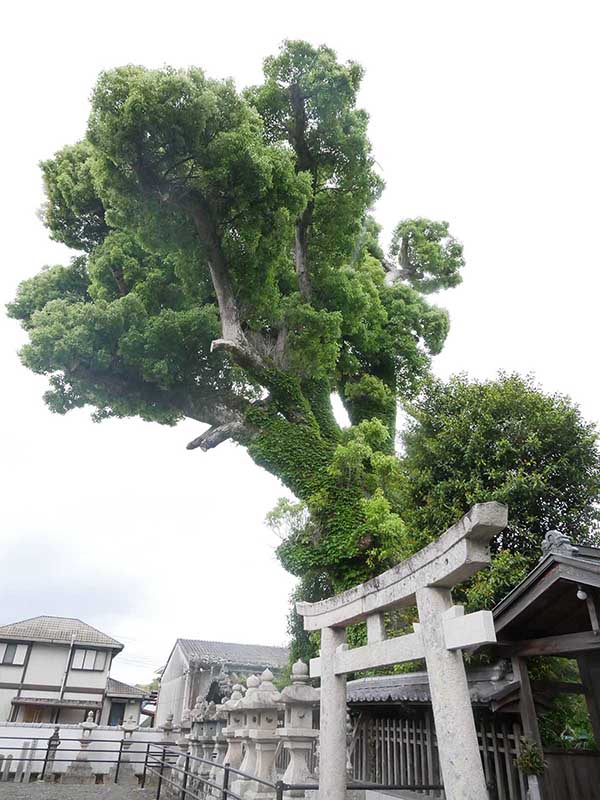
[156, 639, 288, 725]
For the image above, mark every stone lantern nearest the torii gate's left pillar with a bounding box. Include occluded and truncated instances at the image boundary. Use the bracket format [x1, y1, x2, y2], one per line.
[277, 660, 319, 797]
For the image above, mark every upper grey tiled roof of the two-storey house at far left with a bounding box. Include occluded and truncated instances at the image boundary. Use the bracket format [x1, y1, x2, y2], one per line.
[0, 616, 123, 650]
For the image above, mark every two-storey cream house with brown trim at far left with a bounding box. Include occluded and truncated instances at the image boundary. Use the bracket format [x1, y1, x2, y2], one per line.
[0, 616, 144, 725]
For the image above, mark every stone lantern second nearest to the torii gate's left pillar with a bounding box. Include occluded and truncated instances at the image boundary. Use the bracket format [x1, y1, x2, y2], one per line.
[241, 669, 281, 800]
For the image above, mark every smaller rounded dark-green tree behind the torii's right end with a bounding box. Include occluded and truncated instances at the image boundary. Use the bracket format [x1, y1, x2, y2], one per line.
[400, 374, 600, 608]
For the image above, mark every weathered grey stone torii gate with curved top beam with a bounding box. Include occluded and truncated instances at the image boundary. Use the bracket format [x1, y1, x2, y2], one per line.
[296, 503, 508, 800]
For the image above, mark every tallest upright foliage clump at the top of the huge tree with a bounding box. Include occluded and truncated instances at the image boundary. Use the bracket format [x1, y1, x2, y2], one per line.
[246, 41, 383, 272]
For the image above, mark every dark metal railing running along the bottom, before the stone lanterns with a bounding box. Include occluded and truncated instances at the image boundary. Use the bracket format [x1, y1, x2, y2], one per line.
[0, 732, 443, 800]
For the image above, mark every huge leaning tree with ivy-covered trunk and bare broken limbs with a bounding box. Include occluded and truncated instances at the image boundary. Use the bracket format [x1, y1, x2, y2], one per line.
[9, 42, 463, 593]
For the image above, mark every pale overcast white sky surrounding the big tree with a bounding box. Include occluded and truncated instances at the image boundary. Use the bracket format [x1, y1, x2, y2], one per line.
[0, 0, 600, 682]
